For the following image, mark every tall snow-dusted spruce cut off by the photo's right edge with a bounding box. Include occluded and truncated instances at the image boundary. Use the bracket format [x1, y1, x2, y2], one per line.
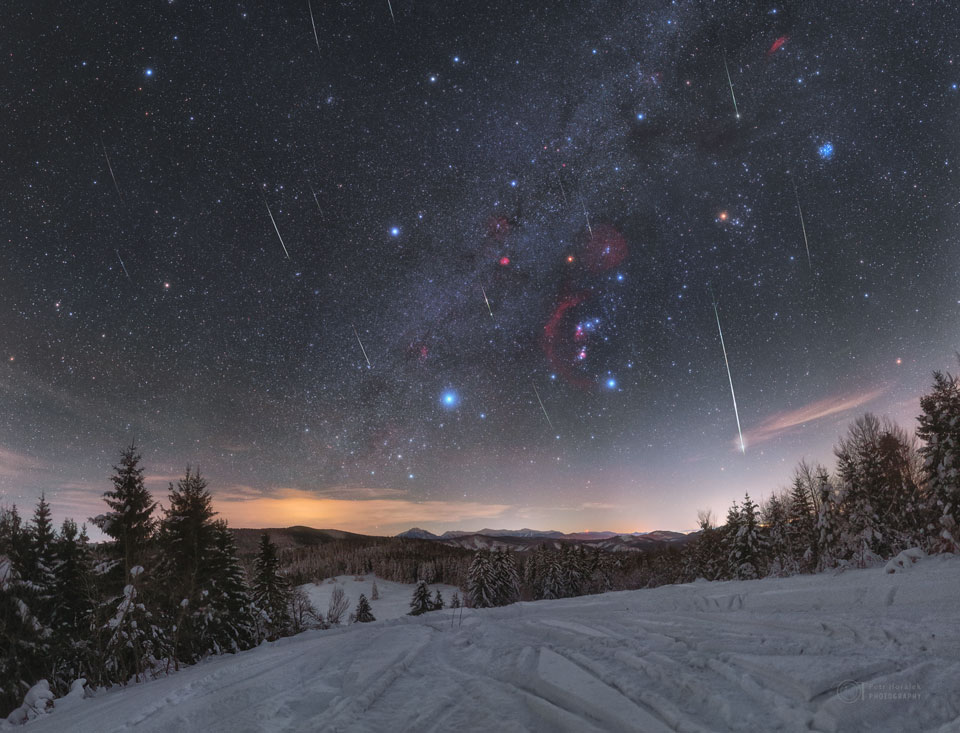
[917, 372, 960, 552]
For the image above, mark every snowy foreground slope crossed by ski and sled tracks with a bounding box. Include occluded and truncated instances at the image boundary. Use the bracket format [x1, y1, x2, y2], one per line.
[15, 556, 960, 733]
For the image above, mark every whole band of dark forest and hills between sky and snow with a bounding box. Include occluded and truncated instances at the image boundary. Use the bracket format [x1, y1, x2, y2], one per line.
[0, 372, 960, 722]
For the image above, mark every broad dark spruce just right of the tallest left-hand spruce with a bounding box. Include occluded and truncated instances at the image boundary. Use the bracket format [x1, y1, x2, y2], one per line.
[157, 467, 216, 666]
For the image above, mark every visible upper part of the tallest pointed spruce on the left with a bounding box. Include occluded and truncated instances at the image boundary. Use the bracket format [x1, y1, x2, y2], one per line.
[91, 443, 157, 583]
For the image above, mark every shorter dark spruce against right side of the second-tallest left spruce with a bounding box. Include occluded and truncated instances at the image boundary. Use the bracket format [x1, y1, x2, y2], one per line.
[206, 520, 260, 654]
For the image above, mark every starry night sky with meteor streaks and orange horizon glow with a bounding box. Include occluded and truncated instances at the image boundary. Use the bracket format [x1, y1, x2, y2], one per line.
[0, 0, 960, 533]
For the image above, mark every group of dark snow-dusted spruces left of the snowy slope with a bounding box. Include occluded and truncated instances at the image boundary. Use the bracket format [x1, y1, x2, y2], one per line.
[0, 445, 304, 717]
